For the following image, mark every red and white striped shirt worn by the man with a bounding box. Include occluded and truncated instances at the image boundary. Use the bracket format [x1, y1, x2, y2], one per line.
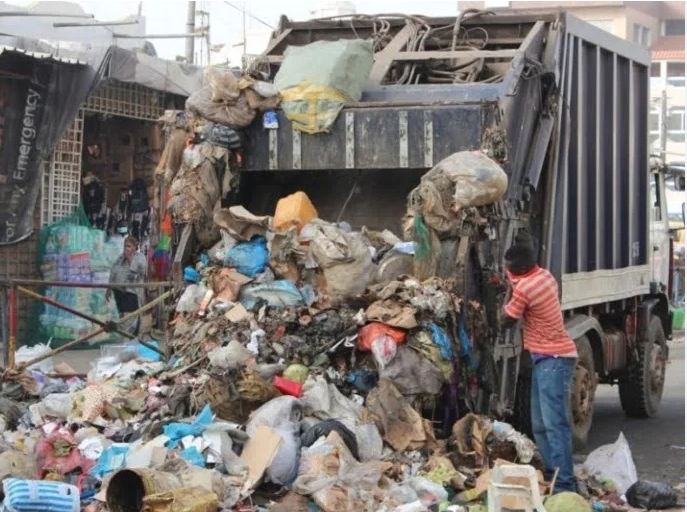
[504, 267, 577, 356]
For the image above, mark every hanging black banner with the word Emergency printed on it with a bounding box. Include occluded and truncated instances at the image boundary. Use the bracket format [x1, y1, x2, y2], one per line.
[0, 47, 97, 245]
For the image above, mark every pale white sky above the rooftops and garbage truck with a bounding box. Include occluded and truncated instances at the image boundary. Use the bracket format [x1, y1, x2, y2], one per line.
[8, 0, 457, 59]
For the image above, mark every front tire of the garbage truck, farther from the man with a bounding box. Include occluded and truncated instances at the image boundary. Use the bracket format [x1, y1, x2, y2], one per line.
[619, 315, 667, 418]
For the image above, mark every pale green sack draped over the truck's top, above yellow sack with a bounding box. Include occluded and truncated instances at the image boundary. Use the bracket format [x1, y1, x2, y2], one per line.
[274, 39, 374, 101]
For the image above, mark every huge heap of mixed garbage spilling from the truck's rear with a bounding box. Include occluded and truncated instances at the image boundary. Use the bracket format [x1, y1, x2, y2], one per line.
[0, 189, 677, 512]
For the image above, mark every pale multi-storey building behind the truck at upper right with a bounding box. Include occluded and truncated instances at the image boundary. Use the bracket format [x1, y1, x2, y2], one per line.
[458, 0, 685, 162]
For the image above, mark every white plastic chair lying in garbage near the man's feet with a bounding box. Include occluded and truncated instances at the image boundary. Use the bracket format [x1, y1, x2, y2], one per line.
[487, 464, 546, 512]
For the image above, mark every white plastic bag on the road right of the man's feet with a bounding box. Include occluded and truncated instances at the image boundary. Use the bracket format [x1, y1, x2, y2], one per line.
[584, 432, 638, 496]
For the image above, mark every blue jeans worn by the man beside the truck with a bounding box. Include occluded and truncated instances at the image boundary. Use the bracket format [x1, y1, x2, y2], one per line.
[531, 357, 577, 492]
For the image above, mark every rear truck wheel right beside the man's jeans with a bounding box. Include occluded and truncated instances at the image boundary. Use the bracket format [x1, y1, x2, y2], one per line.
[570, 336, 596, 450]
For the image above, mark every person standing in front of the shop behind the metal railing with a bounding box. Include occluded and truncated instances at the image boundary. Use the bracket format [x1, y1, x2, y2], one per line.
[106, 236, 148, 336]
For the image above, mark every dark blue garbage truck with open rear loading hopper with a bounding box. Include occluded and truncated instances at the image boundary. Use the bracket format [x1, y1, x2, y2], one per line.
[204, 11, 672, 446]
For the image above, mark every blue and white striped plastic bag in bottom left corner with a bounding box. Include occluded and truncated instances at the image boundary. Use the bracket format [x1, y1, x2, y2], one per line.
[2, 478, 81, 512]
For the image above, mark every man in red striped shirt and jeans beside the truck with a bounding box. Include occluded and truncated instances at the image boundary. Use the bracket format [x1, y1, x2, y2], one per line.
[503, 234, 577, 492]
